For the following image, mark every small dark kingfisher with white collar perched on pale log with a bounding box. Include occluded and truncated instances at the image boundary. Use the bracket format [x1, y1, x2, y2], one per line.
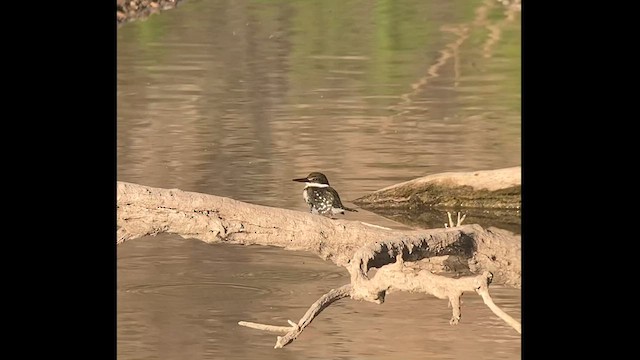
[293, 172, 358, 215]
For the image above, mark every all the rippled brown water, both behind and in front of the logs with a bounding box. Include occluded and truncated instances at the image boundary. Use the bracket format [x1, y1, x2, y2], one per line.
[117, 0, 521, 359]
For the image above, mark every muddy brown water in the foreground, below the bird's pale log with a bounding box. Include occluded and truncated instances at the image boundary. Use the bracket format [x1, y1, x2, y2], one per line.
[117, 235, 520, 359]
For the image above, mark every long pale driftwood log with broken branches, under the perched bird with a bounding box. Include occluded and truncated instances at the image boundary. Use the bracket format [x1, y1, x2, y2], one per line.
[116, 182, 521, 347]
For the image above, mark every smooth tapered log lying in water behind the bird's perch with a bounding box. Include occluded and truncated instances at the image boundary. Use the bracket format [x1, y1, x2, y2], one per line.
[353, 166, 522, 233]
